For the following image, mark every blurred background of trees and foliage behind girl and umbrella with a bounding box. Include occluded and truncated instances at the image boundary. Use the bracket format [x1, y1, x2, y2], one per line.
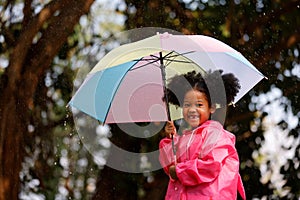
[0, 0, 300, 200]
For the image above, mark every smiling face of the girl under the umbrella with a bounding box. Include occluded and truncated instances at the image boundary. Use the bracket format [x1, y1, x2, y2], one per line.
[183, 90, 215, 128]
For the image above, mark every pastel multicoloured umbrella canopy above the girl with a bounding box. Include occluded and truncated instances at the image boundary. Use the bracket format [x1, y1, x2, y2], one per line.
[69, 33, 264, 124]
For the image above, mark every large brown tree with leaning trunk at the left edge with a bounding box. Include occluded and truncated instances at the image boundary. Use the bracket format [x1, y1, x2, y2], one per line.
[0, 0, 94, 199]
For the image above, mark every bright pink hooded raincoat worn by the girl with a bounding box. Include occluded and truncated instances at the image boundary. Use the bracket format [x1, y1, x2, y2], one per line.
[159, 120, 246, 200]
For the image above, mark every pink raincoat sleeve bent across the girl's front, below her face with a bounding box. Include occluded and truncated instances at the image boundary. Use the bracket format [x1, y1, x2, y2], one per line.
[176, 127, 239, 186]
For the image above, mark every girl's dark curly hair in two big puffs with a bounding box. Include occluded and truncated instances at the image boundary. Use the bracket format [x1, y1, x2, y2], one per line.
[163, 70, 241, 106]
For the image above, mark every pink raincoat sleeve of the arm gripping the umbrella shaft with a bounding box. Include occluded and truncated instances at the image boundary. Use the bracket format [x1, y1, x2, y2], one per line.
[159, 136, 178, 175]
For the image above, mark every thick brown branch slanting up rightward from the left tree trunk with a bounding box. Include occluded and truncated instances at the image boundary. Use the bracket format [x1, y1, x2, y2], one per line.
[21, 0, 94, 108]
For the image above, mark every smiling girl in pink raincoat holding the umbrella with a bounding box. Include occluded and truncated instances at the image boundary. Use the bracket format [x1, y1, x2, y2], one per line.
[159, 70, 246, 200]
